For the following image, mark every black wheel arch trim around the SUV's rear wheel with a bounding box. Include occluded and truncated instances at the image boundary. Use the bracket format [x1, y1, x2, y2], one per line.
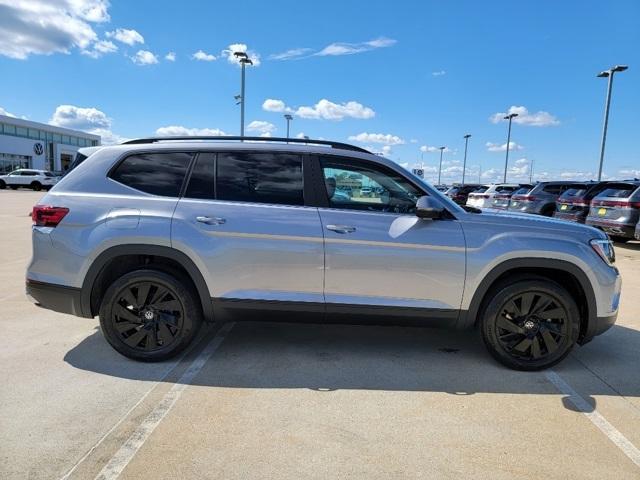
[80, 244, 213, 321]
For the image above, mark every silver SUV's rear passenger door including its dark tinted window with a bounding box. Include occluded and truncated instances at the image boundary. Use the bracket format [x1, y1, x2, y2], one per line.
[171, 151, 324, 310]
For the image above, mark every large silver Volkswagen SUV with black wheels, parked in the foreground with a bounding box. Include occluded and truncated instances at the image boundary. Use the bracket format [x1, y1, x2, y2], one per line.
[26, 137, 620, 370]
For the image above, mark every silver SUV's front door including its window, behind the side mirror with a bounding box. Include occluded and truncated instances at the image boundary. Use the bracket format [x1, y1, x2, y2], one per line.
[319, 156, 465, 321]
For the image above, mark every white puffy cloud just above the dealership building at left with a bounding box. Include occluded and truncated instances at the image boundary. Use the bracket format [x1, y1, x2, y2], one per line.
[49, 105, 127, 145]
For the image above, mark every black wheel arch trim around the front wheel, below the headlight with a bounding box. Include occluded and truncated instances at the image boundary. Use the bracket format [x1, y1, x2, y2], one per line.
[458, 258, 597, 343]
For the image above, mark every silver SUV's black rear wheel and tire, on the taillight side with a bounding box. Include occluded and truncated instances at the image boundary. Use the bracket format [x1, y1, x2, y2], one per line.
[99, 269, 202, 362]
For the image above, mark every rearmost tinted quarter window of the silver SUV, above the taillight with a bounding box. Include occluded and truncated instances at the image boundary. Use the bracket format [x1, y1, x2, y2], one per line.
[111, 152, 192, 197]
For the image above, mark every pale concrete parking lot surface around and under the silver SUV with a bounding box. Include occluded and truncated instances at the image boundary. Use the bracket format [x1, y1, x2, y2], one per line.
[0, 190, 640, 479]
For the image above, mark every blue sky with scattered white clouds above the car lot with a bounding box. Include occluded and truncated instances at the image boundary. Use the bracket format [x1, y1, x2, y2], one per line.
[0, 0, 640, 181]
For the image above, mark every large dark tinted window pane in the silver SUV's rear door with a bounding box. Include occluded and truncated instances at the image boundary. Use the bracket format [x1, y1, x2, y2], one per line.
[216, 152, 304, 205]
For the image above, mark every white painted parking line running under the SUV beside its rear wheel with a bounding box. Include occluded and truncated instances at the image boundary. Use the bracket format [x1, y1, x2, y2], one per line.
[96, 323, 234, 480]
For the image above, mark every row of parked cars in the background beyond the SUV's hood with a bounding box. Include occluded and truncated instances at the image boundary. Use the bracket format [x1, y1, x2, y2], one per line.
[458, 179, 640, 242]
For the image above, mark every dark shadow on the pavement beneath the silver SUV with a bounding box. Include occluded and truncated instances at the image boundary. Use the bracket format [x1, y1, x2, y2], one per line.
[65, 322, 640, 409]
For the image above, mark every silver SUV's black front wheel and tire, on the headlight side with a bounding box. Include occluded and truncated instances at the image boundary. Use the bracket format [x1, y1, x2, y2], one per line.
[480, 276, 580, 371]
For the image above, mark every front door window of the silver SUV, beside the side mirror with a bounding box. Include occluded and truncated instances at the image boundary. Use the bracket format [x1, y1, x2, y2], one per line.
[321, 157, 422, 213]
